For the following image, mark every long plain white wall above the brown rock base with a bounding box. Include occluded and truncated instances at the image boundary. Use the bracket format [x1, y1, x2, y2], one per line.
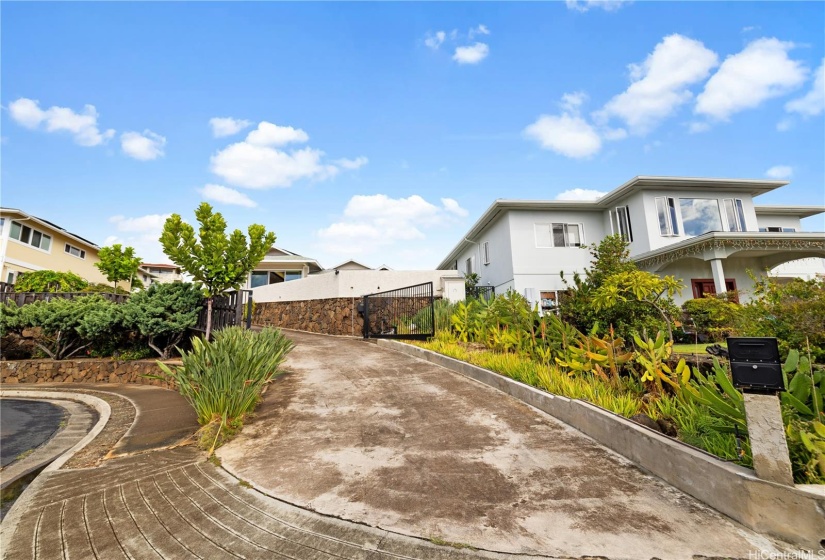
[252, 270, 463, 302]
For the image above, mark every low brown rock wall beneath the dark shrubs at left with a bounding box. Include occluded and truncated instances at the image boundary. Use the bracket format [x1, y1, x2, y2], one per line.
[0, 358, 174, 389]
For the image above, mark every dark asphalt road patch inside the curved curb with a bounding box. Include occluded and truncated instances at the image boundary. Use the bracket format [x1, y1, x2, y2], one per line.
[0, 399, 66, 467]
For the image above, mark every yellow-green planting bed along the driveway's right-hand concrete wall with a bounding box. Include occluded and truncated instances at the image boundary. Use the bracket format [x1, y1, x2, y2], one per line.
[415, 293, 825, 483]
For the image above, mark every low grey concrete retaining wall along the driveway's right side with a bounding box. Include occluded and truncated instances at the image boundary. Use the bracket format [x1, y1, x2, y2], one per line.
[378, 340, 825, 550]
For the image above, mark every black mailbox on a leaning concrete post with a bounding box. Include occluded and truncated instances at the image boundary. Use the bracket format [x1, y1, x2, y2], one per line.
[727, 337, 793, 486]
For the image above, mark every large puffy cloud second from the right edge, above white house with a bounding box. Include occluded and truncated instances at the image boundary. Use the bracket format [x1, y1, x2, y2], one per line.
[694, 38, 808, 121]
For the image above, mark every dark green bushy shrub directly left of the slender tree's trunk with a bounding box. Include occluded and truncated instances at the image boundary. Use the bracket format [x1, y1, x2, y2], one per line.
[122, 282, 203, 360]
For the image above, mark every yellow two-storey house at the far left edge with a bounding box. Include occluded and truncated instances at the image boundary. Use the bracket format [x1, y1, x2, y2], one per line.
[0, 208, 134, 288]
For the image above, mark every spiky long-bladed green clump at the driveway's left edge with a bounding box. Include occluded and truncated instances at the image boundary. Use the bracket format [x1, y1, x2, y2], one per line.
[158, 327, 293, 454]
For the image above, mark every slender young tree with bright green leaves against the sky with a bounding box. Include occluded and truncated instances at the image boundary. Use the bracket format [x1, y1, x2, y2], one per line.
[160, 202, 275, 340]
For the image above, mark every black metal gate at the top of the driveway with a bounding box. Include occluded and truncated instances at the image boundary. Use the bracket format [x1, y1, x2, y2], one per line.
[361, 282, 435, 340]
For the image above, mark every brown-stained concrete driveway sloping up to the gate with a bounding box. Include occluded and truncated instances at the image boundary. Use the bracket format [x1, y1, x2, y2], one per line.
[218, 332, 785, 558]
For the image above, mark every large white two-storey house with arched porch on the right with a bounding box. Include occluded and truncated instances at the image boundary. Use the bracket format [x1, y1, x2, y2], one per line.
[438, 177, 825, 310]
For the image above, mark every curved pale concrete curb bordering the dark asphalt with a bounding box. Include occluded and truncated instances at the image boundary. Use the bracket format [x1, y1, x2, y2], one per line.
[0, 389, 112, 558]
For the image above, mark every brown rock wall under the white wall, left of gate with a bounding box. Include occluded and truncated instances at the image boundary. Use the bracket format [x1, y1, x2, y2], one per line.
[252, 298, 364, 336]
